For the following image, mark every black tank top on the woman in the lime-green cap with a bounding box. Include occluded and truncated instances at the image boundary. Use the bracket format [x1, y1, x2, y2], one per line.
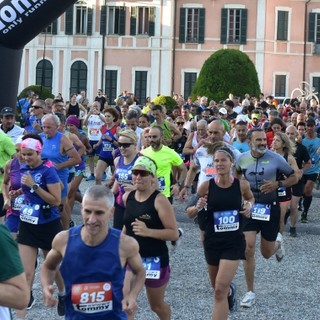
[124, 190, 169, 268]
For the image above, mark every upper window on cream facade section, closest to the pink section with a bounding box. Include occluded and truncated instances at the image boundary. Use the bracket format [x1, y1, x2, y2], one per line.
[130, 7, 155, 36]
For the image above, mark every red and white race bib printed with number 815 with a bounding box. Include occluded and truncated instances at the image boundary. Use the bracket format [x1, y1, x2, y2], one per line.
[71, 282, 113, 314]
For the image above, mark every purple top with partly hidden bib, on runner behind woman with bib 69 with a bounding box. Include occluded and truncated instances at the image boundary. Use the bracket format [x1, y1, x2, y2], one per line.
[7, 158, 24, 216]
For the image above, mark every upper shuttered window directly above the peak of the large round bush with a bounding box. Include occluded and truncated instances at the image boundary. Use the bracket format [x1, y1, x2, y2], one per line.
[220, 9, 248, 44]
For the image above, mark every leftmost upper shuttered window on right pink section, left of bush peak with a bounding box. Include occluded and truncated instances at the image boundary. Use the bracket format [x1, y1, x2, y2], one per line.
[179, 8, 205, 43]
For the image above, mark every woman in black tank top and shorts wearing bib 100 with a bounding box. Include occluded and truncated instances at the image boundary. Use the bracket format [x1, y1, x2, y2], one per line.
[189, 147, 254, 320]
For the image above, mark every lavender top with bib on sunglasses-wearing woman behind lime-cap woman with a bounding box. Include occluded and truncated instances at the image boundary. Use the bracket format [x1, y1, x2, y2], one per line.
[114, 153, 140, 207]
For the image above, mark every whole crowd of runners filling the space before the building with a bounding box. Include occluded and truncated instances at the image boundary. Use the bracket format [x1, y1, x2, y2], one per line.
[0, 90, 320, 320]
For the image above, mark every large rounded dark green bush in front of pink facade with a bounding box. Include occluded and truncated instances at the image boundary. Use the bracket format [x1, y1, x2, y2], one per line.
[192, 49, 261, 101]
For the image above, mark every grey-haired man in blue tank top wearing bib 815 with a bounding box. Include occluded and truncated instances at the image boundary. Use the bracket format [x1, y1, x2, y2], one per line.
[41, 185, 145, 320]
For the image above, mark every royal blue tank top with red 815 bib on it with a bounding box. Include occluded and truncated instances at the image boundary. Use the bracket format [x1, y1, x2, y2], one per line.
[60, 226, 127, 320]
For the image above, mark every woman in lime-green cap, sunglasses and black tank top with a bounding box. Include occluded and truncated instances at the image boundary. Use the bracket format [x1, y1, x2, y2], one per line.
[123, 156, 179, 319]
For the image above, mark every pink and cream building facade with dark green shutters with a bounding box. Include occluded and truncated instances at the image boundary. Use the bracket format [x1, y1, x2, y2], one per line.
[19, 0, 320, 104]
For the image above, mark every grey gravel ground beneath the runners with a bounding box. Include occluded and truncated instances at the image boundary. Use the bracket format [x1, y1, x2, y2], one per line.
[12, 182, 320, 320]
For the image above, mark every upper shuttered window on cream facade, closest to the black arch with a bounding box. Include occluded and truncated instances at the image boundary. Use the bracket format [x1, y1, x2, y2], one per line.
[65, 1, 93, 35]
